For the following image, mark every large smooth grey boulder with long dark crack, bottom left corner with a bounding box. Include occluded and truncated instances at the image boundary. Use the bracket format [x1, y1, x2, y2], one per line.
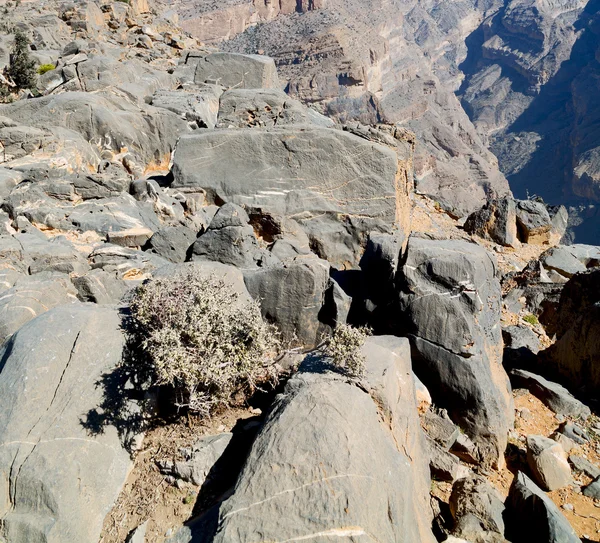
[0, 304, 131, 543]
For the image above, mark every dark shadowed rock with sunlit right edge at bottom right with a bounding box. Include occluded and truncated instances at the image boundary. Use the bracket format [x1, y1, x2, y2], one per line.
[505, 472, 581, 543]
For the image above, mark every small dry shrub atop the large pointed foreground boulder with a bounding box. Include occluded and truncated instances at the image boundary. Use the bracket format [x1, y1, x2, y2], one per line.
[324, 324, 371, 379]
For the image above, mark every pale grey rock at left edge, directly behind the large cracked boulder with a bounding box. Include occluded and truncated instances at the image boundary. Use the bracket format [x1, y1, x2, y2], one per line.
[0, 274, 77, 345]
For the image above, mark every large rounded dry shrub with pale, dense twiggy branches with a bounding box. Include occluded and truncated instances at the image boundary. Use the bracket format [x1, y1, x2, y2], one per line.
[131, 269, 279, 415]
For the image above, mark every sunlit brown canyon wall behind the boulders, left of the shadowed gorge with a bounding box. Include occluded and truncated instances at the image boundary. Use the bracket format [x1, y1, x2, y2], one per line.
[173, 0, 508, 215]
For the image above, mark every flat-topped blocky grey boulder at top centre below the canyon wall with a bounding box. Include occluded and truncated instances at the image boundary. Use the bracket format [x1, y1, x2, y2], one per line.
[194, 53, 279, 89]
